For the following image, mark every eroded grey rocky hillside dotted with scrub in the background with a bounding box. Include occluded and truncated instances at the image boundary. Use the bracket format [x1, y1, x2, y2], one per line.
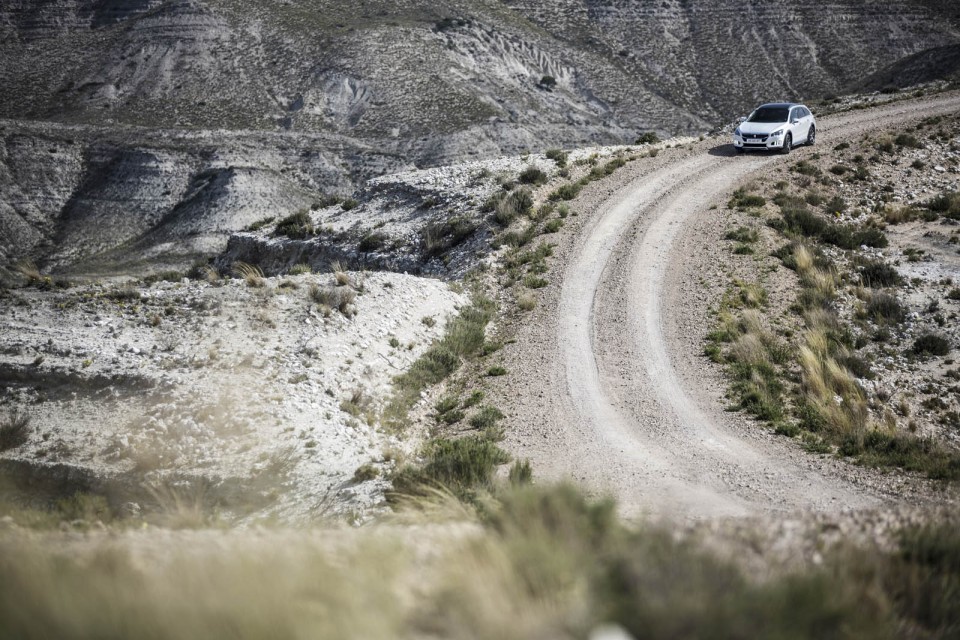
[0, 0, 960, 274]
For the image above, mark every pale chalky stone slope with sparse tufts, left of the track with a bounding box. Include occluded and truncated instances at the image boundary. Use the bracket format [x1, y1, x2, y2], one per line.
[0, 273, 468, 518]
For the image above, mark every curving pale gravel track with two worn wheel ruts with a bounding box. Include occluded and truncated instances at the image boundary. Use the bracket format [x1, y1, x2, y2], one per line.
[505, 94, 960, 518]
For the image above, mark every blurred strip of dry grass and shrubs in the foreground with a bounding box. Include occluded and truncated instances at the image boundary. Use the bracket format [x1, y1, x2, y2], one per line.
[0, 485, 960, 639]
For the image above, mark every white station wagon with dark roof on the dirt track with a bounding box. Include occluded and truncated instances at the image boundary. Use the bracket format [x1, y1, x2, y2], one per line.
[733, 102, 817, 153]
